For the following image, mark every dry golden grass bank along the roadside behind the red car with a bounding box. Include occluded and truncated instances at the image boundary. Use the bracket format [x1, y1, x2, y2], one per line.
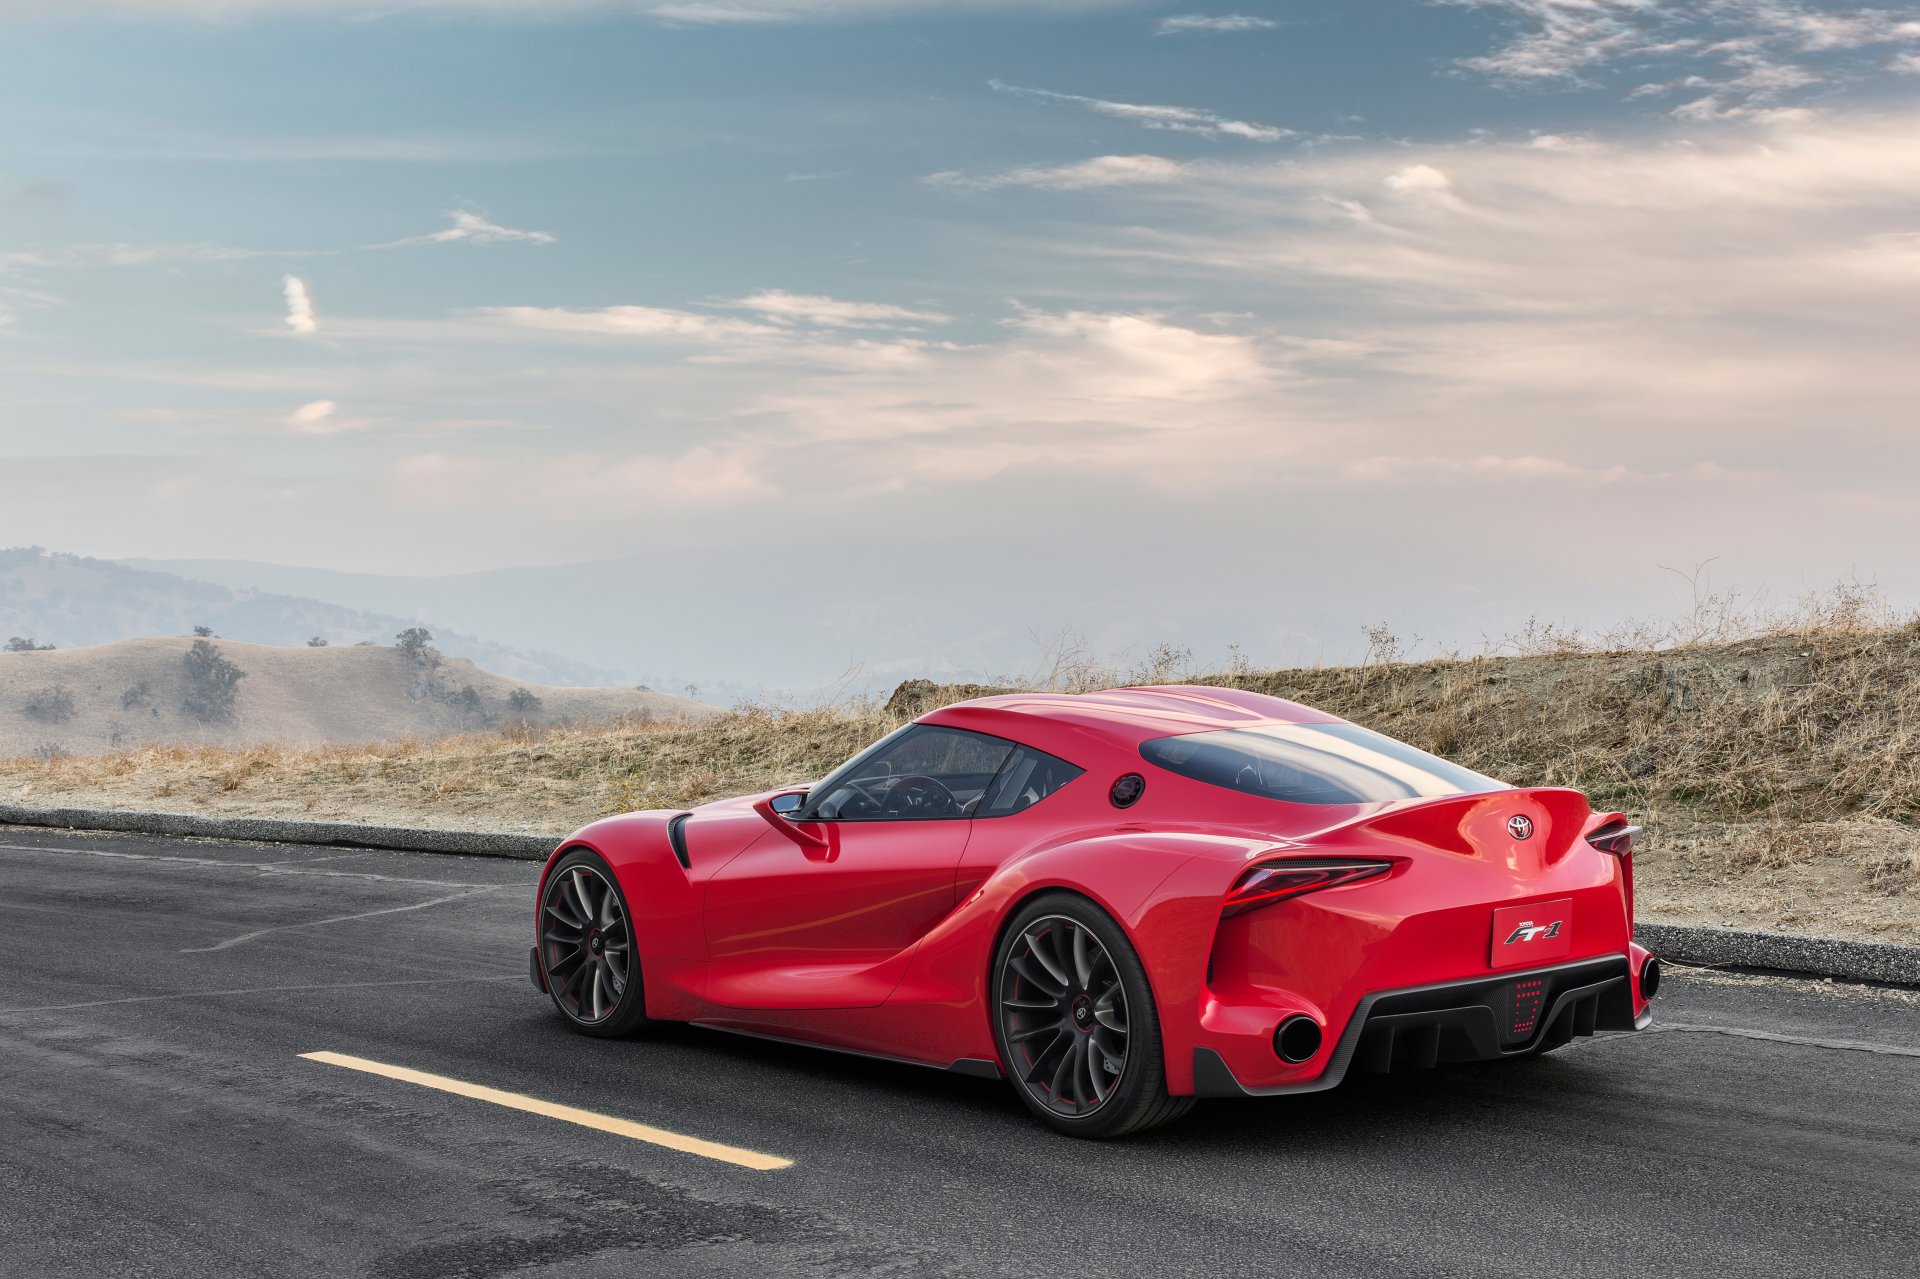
[0, 611, 1920, 941]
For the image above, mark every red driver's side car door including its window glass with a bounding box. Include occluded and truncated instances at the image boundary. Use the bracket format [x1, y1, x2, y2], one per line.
[705, 726, 1014, 1008]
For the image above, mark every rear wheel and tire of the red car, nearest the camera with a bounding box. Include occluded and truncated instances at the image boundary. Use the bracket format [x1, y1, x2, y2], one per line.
[991, 893, 1194, 1139]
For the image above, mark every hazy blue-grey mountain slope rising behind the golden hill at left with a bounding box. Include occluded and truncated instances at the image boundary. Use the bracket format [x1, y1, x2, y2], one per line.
[0, 547, 628, 688]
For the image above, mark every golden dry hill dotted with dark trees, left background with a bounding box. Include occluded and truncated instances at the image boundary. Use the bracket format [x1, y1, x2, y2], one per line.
[0, 640, 714, 755]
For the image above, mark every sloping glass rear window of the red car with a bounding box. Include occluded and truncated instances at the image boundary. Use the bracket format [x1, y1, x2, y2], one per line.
[1140, 724, 1507, 805]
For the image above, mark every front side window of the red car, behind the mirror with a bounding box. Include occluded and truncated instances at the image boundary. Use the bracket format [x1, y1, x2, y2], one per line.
[801, 726, 1014, 822]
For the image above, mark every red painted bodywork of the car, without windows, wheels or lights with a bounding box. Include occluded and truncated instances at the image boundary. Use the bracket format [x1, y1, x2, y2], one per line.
[533, 688, 1644, 1095]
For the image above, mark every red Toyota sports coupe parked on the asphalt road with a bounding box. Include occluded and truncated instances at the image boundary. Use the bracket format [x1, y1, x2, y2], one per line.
[532, 688, 1659, 1137]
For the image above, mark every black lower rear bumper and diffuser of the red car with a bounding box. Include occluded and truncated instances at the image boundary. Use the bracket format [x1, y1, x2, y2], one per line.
[1194, 954, 1651, 1097]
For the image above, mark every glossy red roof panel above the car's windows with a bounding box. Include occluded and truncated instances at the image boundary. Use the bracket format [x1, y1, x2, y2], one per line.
[922, 684, 1344, 749]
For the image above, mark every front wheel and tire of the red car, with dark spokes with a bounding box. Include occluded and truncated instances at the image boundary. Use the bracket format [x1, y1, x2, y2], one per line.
[540, 849, 649, 1039]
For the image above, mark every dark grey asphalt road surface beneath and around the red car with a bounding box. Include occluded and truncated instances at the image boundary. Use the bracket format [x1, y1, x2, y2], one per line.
[0, 830, 1920, 1279]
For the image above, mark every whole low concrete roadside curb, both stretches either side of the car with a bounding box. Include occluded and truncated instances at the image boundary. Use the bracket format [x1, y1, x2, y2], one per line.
[0, 805, 1920, 985]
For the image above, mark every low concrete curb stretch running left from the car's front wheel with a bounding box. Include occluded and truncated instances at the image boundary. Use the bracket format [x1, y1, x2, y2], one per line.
[0, 805, 564, 862]
